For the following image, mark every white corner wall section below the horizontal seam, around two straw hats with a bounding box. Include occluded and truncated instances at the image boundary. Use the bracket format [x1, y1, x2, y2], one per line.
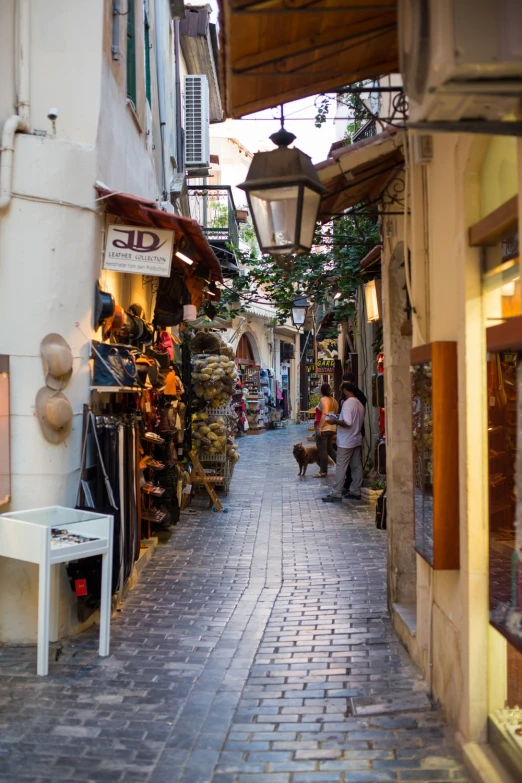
[0, 135, 101, 643]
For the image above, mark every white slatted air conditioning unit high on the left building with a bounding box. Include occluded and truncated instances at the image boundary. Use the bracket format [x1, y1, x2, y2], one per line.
[185, 74, 210, 169]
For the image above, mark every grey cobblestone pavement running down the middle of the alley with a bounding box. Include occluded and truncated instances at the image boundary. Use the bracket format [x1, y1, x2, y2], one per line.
[0, 426, 468, 783]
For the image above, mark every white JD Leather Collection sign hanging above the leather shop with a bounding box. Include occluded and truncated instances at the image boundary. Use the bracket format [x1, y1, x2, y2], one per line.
[103, 225, 174, 277]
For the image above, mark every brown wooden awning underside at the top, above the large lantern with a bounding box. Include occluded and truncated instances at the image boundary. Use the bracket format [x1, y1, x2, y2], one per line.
[219, 0, 399, 117]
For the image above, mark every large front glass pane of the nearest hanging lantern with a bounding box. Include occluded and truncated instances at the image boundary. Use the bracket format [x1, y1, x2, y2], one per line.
[249, 185, 299, 253]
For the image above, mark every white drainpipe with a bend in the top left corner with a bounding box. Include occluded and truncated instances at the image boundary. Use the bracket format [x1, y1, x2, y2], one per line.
[0, 0, 31, 212]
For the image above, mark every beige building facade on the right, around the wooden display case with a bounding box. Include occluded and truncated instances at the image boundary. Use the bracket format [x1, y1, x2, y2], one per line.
[383, 133, 522, 780]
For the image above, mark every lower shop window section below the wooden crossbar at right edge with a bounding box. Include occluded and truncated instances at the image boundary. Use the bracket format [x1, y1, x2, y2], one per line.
[487, 328, 522, 774]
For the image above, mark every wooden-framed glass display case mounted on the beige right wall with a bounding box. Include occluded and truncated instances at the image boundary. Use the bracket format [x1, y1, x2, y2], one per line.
[411, 342, 459, 569]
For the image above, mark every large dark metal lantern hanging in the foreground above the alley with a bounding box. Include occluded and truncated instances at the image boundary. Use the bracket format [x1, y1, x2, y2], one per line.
[238, 116, 325, 255]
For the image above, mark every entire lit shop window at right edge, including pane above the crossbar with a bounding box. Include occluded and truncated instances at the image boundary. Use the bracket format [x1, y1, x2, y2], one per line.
[483, 230, 522, 779]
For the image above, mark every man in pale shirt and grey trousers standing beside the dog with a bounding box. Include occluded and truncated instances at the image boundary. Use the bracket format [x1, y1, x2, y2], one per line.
[323, 382, 364, 503]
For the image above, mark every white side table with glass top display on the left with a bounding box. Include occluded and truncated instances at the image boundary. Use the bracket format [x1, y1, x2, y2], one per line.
[0, 506, 114, 675]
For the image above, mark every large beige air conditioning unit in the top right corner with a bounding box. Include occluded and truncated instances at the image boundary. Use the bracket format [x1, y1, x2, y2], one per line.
[399, 0, 522, 123]
